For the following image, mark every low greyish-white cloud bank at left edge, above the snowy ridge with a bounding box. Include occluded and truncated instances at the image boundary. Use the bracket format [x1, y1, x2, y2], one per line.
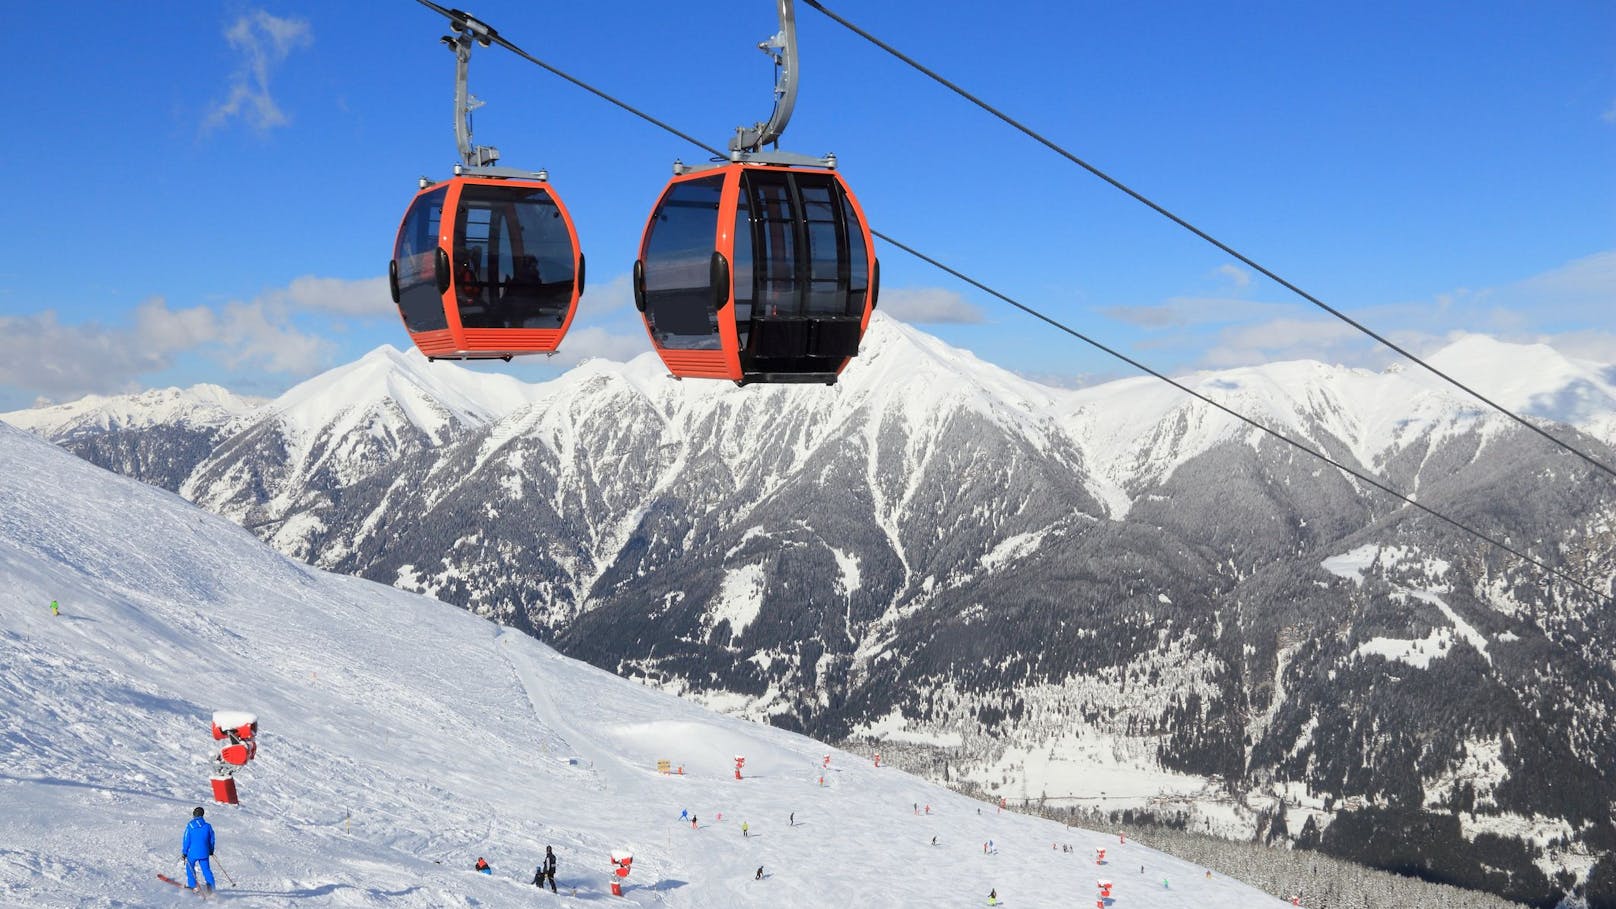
[0, 298, 333, 400]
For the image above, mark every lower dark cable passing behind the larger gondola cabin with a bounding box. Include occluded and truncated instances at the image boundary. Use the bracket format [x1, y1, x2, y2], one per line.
[397, 0, 1616, 605]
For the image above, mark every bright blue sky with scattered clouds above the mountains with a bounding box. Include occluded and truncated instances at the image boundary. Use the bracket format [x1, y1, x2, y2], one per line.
[0, 0, 1616, 402]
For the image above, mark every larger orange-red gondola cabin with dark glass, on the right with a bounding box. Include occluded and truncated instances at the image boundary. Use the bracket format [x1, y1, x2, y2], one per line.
[633, 163, 881, 385]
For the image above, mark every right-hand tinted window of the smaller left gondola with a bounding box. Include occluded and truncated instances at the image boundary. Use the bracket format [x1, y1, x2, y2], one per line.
[452, 183, 577, 328]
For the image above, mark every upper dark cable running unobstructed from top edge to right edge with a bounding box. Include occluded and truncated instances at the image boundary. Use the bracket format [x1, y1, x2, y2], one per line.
[803, 0, 1616, 477]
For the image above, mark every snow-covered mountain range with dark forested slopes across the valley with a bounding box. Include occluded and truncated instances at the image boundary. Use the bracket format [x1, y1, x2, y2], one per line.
[8, 319, 1616, 904]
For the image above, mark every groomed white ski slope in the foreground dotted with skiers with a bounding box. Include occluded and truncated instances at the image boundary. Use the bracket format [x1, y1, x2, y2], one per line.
[0, 425, 1285, 909]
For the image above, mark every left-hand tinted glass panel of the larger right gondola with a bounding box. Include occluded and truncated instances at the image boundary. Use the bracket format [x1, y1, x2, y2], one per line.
[645, 175, 724, 349]
